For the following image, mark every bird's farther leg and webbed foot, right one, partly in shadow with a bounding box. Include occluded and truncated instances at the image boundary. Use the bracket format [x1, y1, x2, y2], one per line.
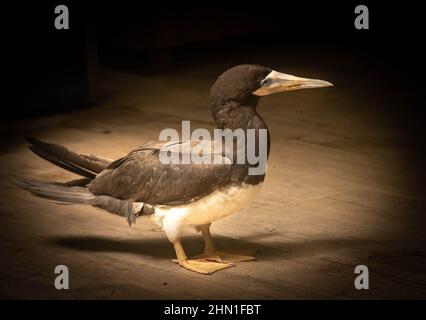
[194, 224, 257, 263]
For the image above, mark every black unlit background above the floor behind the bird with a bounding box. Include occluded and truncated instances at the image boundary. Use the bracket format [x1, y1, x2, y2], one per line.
[2, 1, 424, 122]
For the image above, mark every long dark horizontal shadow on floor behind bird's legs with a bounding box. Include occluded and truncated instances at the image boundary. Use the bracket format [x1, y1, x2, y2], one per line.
[48, 235, 371, 261]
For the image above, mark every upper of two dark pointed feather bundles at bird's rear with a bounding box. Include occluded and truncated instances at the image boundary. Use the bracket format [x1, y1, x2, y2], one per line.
[25, 137, 112, 179]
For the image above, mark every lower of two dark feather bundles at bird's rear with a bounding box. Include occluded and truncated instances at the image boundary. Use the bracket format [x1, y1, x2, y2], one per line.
[14, 177, 96, 204]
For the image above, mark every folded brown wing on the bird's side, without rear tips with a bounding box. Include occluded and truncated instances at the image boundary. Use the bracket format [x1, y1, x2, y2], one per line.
[89, 140, 231, 205]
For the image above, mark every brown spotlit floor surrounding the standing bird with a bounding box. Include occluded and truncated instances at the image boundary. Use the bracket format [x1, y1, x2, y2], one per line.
[0, 58, 426, 299]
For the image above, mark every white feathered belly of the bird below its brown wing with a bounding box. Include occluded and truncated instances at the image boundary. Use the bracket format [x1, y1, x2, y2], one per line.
[152, 183, 262, 226]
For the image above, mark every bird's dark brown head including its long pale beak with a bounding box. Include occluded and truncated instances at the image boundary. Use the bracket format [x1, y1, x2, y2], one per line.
[210, 64, 333, 103]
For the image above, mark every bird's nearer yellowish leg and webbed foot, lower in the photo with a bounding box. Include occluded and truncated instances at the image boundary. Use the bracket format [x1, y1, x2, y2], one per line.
[173, 240, 235, 274]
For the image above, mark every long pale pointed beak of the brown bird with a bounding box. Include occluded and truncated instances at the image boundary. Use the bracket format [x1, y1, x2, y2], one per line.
[253, 71, 333, 96]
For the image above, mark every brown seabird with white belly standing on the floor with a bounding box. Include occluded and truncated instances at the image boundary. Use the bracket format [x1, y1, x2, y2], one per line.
[15, 64, 333, 274]
